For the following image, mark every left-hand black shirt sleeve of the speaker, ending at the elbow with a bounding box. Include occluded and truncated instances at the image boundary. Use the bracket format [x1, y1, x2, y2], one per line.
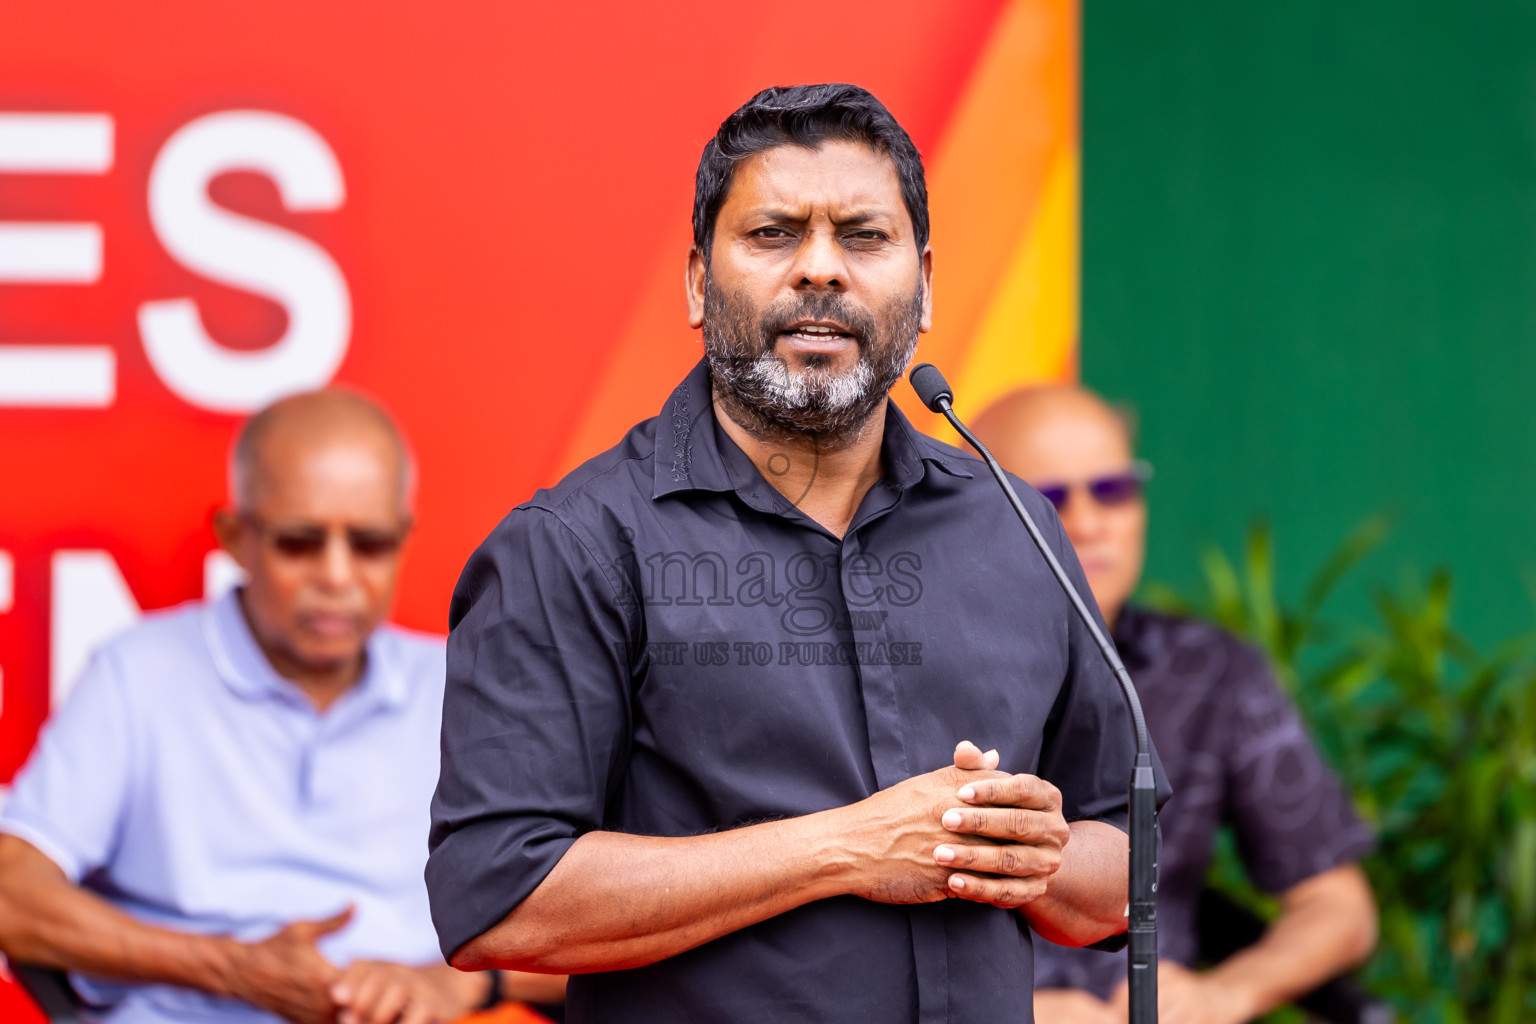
[425, 507, 633, 956]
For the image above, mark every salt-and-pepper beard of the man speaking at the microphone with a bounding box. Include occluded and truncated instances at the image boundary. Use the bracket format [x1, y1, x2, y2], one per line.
[703, 276, 923, 448]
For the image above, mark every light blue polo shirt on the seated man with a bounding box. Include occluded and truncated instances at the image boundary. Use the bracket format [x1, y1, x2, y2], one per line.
[0, 593, 444, 1024]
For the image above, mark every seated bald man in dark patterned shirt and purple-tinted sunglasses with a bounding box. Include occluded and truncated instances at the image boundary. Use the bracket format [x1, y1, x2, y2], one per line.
[975, 388, 1376, 1024]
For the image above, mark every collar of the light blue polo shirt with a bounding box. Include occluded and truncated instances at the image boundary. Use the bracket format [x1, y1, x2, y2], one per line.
[203, 588, 409, 708]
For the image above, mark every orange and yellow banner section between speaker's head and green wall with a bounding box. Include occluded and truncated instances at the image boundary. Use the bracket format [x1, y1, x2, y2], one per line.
[895, 0, 1078, 431]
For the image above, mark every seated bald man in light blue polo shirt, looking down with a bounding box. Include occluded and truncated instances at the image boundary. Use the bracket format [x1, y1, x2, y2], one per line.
[0, 391, 564, 1024]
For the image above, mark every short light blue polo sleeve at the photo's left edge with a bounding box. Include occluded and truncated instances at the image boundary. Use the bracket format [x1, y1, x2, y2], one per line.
[0, 651, 134, 883]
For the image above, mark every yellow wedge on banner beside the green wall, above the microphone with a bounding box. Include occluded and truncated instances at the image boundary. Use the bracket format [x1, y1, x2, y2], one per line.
[946, 150, 1078, 426]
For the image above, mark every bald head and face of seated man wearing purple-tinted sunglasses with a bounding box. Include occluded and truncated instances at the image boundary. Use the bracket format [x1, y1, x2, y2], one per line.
[975, 387, 1146, 623]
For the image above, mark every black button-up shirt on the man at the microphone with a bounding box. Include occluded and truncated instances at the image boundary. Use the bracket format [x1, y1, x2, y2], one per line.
[427, 364, 1155, 1024]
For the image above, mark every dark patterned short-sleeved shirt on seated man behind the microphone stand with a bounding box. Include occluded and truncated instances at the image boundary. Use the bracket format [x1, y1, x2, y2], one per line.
[1035, 608, 1373, 996]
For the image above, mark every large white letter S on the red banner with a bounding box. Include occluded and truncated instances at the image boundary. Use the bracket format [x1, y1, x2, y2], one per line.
[138, 111, 352, 413]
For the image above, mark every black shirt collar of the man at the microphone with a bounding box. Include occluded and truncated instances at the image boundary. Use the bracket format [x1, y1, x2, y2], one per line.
[651, 359, 972, 504]
